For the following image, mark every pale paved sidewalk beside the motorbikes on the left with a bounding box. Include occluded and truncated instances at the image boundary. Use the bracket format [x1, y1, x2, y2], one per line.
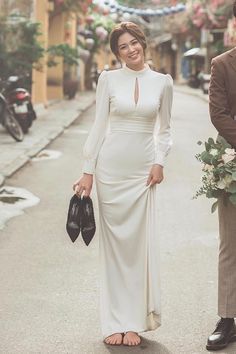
[0, 91, 95, 186]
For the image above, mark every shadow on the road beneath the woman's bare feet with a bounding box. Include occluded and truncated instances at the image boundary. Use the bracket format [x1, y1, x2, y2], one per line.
[105, 337, 172, 354]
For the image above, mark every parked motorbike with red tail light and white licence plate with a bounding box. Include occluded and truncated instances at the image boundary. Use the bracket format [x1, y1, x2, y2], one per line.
[5, 76, 36, 133]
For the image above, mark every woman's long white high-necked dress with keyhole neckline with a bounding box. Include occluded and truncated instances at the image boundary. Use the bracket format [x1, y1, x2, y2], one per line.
[83, 65, 173, 338]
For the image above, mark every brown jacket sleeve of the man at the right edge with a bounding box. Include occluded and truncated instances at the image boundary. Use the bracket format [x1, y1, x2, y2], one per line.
[209, 59, 236, 146]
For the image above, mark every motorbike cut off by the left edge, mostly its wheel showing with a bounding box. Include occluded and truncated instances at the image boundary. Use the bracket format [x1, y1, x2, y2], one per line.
[0, 81, 24, 141]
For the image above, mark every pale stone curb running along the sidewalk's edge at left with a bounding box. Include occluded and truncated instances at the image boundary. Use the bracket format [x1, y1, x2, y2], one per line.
[0, 97, 95, 187]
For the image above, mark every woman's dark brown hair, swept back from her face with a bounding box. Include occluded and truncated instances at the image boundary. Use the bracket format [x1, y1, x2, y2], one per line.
[110, 22, 147, 58]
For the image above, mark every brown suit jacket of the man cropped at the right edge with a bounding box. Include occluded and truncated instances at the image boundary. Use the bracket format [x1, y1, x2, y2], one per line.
[209, 48, 236, 147]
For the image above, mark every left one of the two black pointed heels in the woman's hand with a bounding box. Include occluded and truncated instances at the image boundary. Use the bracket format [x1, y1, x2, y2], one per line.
[66, 194, 81, 242]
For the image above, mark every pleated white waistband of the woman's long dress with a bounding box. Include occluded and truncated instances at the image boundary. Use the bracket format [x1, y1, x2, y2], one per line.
[110, 116, 155, 134]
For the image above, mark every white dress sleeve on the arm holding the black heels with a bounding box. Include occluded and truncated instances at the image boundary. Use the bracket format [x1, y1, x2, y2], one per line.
[82, 71, 109, 174]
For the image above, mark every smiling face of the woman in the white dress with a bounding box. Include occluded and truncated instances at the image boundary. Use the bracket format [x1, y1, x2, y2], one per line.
[118, 32, 144, 69]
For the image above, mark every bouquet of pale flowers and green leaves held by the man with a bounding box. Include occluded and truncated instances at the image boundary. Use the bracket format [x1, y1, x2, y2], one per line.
[194, 137, 236, 213]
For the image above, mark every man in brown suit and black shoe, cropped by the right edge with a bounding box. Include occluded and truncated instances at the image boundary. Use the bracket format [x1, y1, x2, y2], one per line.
[206, 1, 236, 350]
